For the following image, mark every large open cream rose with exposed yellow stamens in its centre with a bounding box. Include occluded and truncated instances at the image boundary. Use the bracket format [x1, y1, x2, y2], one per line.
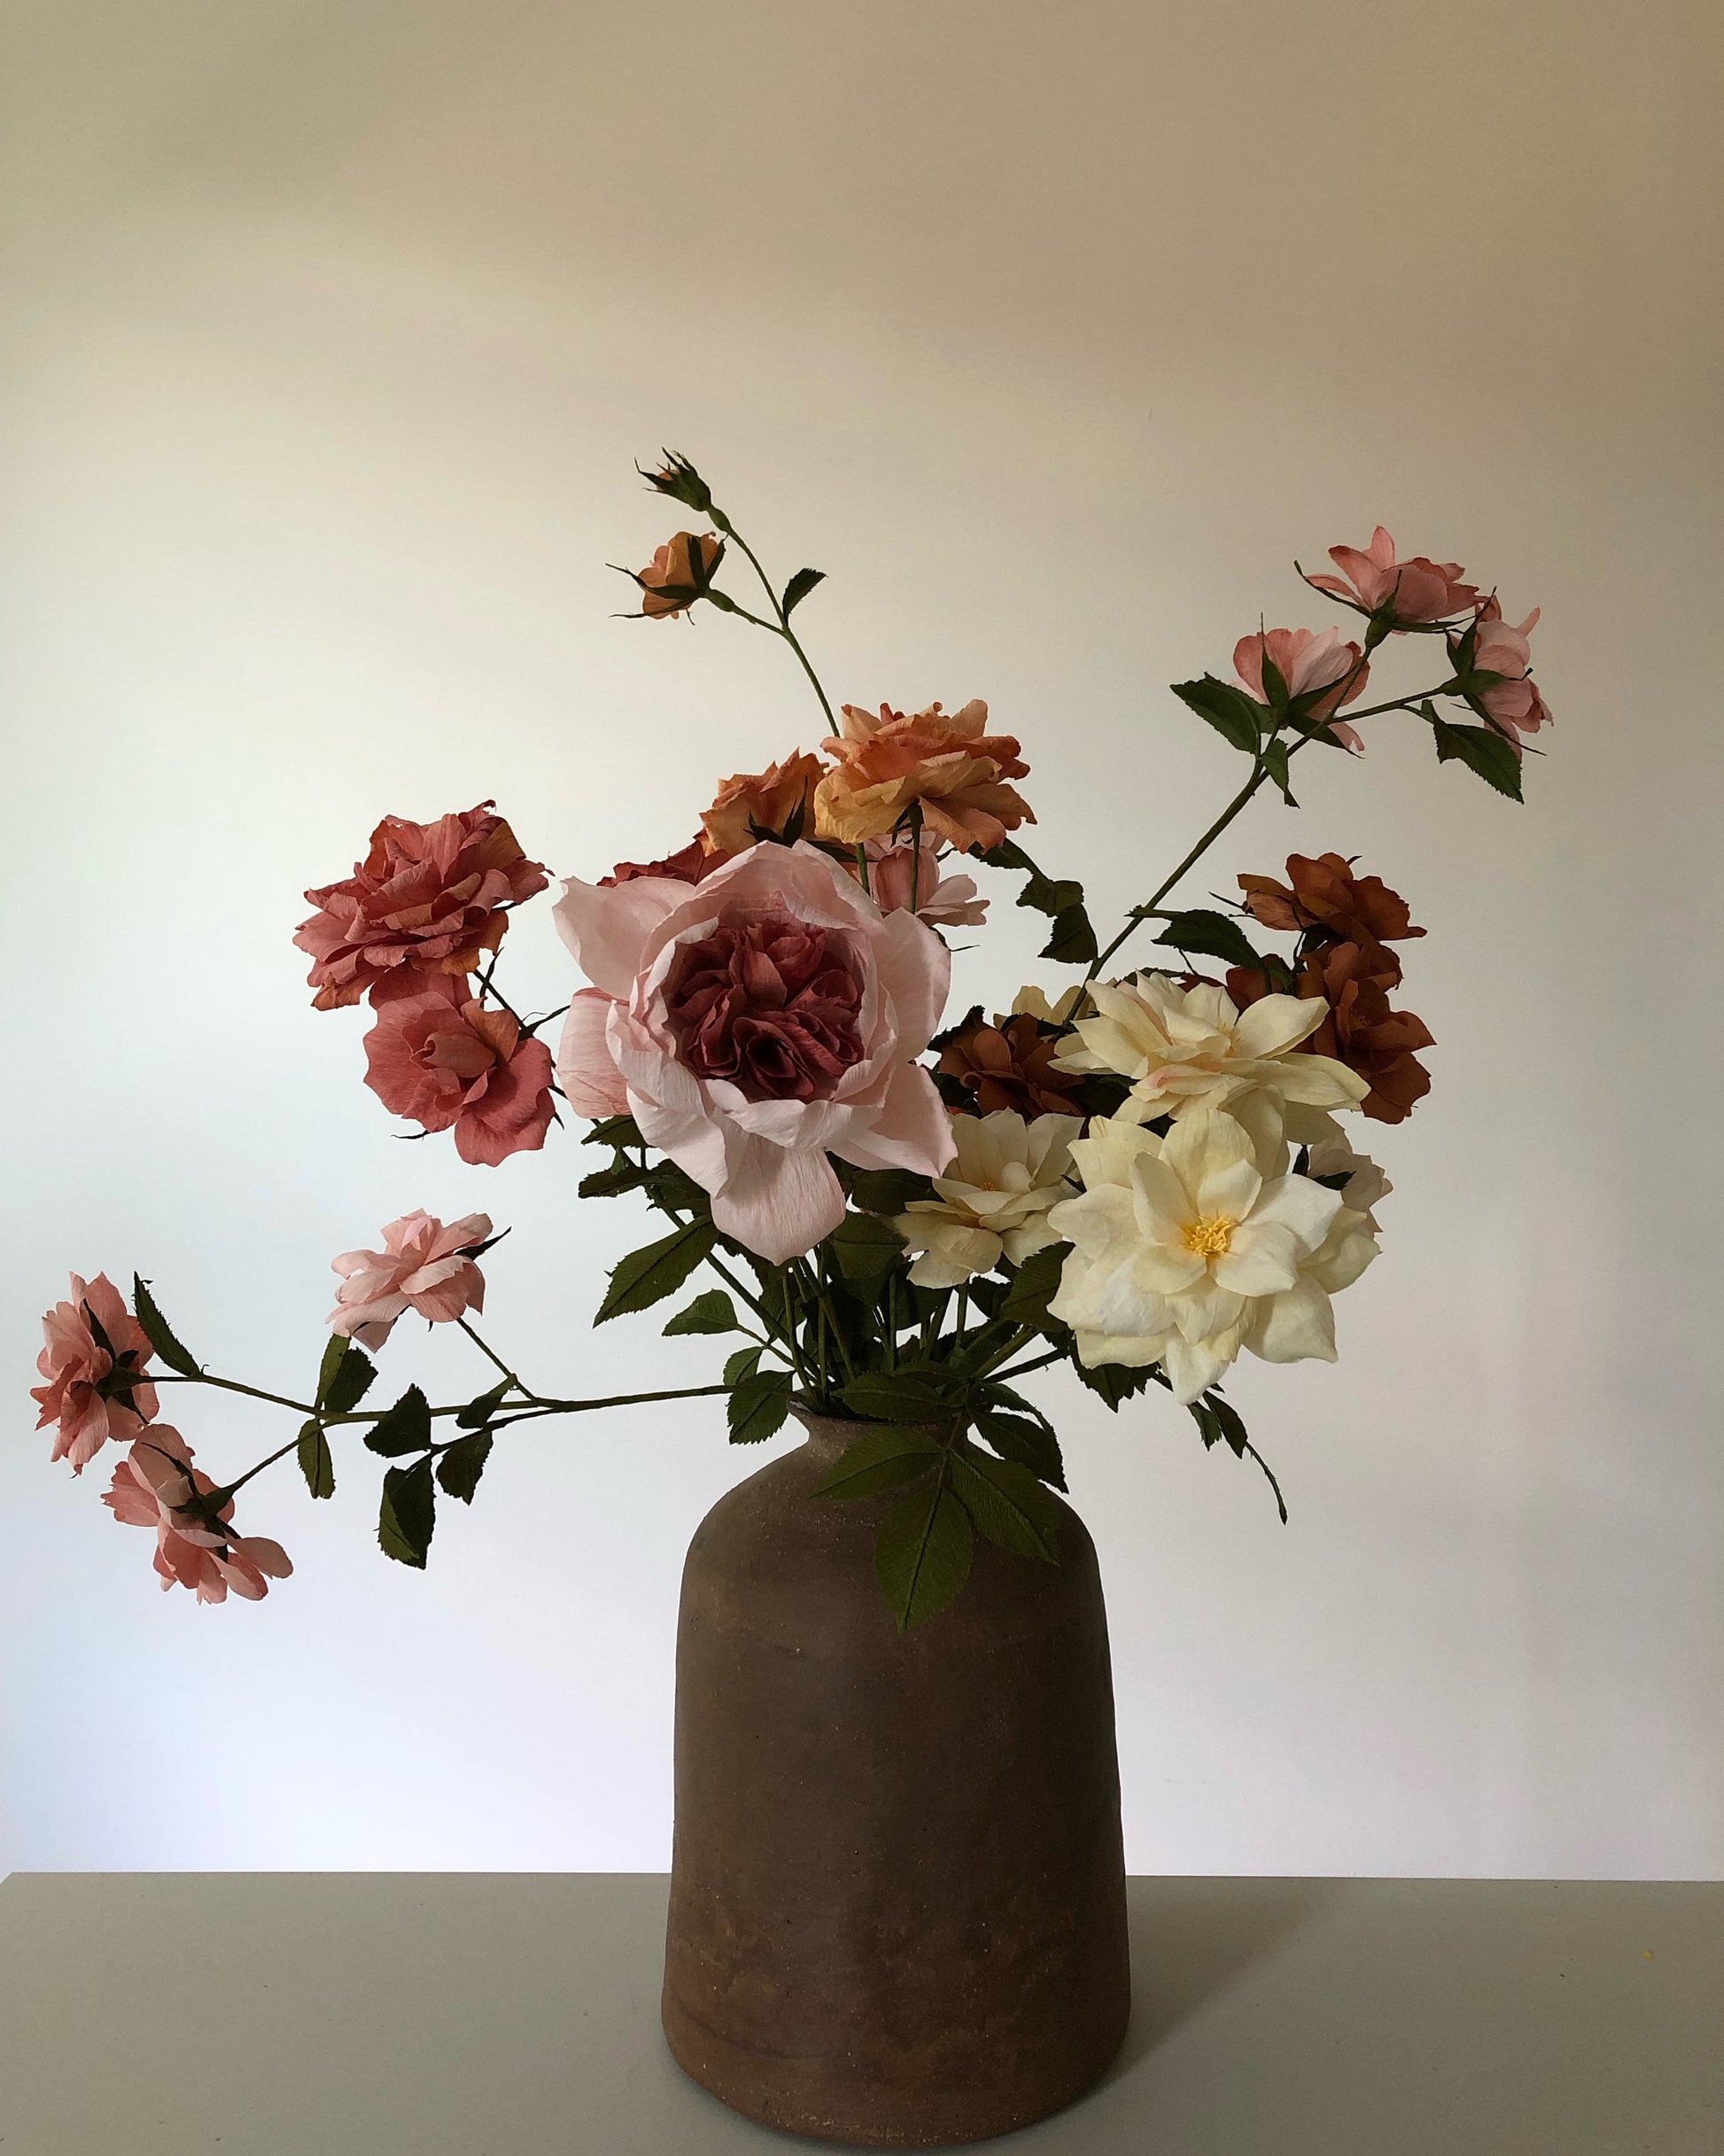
[1047, 1109, 1377, 1405]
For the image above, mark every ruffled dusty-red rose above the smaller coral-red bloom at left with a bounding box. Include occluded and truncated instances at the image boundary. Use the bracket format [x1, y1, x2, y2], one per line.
[293, 802, 545, 1011]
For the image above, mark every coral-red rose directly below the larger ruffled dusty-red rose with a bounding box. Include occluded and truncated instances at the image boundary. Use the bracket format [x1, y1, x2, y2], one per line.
[364, 977, 556, 1169]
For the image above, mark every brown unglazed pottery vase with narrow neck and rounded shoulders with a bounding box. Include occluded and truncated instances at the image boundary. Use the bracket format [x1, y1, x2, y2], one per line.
[664, 1416, 1131, 2147]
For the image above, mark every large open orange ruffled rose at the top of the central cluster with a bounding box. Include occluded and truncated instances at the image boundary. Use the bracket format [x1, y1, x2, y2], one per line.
[814, 698, 1035, 853]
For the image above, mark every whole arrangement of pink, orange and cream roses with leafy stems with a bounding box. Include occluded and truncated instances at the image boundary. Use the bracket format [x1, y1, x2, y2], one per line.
[35, 455, 1549, 1625]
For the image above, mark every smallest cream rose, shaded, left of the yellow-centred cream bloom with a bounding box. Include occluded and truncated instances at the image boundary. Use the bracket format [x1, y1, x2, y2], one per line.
[892, 1109, 1084, 1288]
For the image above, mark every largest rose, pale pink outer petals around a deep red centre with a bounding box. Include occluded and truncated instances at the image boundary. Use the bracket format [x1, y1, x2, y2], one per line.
[556, 843, 952, 1264]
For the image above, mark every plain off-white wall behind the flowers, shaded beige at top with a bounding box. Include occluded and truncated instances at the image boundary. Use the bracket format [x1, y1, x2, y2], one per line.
[0, 0, 1724, 1876]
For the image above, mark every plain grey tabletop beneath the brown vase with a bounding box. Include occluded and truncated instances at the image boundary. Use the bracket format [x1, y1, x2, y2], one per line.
[0, 1872, 1724, 2156]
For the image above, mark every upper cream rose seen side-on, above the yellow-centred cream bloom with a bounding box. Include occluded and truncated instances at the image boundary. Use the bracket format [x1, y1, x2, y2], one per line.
[1056, 972, 1371, 1175]
